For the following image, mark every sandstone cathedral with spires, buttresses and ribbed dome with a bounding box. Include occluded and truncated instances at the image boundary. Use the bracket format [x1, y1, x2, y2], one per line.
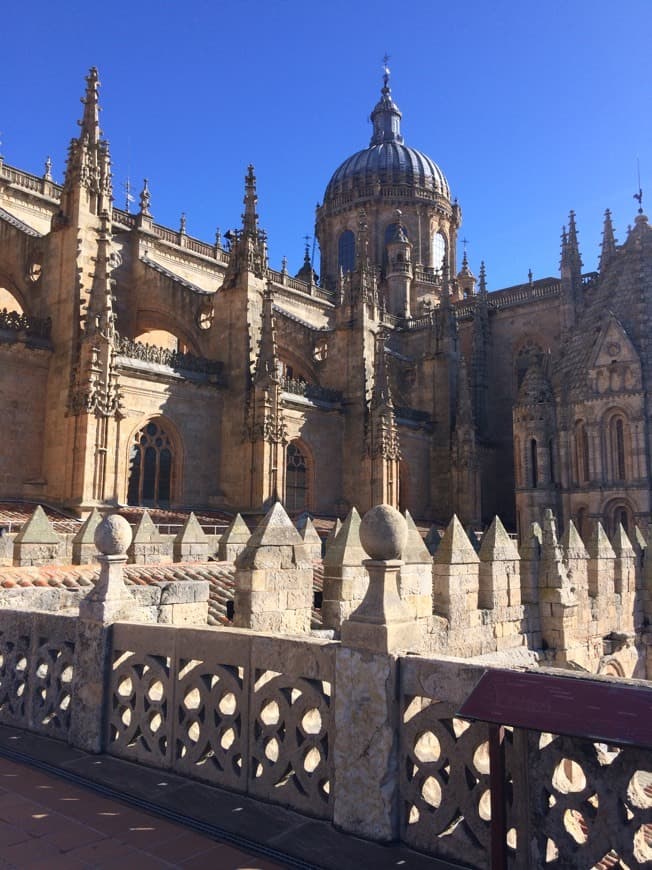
[0, 69, 652, 538]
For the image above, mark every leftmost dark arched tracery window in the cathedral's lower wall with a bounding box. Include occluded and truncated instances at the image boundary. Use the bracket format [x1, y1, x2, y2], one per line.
[127, 420, 173, 507]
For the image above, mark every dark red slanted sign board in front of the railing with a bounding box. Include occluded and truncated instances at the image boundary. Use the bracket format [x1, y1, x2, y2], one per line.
[458, 670, 652, 749]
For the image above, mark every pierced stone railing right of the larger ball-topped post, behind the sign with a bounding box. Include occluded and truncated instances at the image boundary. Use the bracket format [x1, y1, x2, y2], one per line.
[399, 657, 652, 870]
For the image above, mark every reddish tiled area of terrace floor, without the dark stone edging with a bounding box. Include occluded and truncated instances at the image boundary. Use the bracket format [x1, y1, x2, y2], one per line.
[0, 757, 282, 870]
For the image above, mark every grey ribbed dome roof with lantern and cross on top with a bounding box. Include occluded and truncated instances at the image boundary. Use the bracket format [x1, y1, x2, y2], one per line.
[324, 69, 450, 202]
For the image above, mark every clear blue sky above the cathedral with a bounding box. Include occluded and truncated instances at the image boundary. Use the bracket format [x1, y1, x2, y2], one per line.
[0, 0, 652, 289]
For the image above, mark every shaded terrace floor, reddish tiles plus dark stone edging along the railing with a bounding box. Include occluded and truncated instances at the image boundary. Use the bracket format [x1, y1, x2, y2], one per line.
[0, 725, 466, 870]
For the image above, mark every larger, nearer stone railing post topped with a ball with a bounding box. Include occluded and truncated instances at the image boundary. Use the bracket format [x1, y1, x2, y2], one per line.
[333, 505, 416, 842]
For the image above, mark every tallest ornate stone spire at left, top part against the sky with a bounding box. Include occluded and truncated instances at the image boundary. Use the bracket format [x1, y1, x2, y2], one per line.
[62, 67, 113, 215]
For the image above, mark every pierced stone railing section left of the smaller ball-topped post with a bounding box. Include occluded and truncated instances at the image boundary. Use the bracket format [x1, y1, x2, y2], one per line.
[0, 610, 77, 740]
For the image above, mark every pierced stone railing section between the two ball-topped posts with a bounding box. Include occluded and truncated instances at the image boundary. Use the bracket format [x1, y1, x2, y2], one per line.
[107, 623, 336, 818]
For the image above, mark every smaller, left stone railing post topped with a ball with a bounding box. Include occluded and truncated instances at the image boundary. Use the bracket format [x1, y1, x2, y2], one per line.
[68, 514, 133, 752]
